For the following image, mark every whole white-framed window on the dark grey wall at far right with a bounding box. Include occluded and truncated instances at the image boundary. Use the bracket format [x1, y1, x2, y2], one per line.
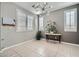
[64, 8, 77, 32]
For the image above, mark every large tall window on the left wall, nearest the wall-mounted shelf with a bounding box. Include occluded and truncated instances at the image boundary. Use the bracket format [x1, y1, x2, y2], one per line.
[16, 9, 26, 32]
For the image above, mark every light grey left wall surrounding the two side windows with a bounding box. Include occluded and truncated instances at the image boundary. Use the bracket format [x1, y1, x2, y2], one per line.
[1, 2, 36, 48]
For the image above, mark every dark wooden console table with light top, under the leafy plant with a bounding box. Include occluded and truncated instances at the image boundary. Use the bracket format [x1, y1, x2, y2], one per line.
[45, 33, 62, 43]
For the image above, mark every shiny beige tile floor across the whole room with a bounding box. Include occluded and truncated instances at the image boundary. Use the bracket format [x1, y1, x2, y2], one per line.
[0, 40, 79, 57]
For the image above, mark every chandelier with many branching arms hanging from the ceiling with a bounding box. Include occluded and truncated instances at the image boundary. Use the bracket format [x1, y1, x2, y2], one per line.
[32, 2, 52, 14]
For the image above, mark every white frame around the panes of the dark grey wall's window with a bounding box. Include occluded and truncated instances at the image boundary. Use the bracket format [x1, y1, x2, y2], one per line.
[64, 8, 77, 32]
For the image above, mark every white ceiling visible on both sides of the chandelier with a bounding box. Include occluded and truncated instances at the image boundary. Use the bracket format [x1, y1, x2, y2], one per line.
[14, 2, 78, 14]
